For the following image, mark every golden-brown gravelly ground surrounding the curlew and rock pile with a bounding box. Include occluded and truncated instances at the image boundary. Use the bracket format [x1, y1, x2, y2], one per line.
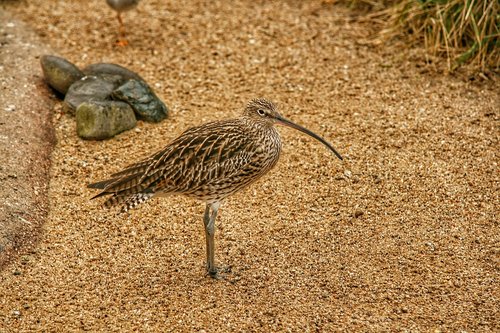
[0, 0, 500, 332]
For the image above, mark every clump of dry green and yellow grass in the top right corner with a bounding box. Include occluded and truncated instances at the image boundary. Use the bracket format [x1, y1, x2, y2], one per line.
[349, 0, 500, 71]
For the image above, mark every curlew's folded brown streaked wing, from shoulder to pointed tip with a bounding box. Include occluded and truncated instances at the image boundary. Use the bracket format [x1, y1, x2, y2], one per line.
[89, 120, 264, 198]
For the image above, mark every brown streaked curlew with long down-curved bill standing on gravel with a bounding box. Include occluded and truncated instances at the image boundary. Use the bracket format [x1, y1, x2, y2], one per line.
[88, 98, 342, 278]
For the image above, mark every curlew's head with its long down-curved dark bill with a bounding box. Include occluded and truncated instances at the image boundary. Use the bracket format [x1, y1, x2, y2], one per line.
[243, 98, 342, 160]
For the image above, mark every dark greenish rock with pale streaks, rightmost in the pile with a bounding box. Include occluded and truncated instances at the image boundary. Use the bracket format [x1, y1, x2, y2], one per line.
[112, 80, 168, 122]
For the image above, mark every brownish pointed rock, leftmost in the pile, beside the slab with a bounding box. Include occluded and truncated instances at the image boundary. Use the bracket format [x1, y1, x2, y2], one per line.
[40, 55, 84, 94]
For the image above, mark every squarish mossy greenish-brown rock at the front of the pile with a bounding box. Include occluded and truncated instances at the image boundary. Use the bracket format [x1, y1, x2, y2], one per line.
[76, 101, 137, 140]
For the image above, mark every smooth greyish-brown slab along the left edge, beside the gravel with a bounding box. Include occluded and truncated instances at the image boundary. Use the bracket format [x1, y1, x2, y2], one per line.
[0, 10, 55, 268]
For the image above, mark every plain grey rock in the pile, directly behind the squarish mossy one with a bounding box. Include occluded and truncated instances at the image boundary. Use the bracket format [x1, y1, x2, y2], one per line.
[64, 76, 117, 112]
